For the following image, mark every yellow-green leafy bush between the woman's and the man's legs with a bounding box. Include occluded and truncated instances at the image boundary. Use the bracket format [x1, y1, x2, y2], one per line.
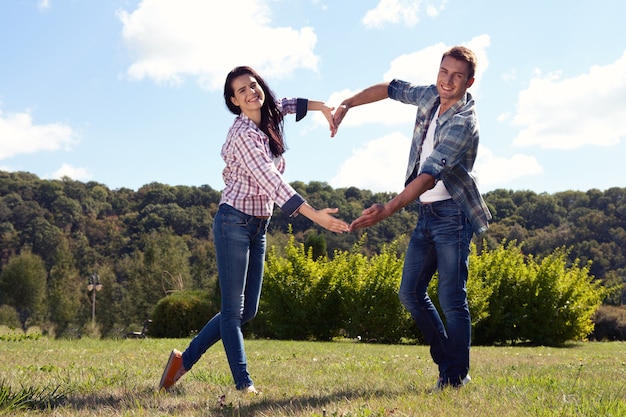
[251, 232, 412, 343]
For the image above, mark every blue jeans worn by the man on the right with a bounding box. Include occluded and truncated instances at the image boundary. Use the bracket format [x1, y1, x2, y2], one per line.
[399, 199, 473, 385]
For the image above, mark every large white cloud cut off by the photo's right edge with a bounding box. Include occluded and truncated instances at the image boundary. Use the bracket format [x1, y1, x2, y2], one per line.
[513, 52, 626, 149]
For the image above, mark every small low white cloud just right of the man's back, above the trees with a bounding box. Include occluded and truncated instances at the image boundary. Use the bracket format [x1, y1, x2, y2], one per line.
[473, 146, 543, 186]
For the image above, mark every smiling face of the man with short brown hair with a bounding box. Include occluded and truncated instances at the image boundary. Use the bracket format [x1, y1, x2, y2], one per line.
[437, 56, 474, 111]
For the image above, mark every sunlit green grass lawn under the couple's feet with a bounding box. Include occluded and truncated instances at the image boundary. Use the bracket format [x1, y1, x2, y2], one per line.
[0, 337, 626, 417]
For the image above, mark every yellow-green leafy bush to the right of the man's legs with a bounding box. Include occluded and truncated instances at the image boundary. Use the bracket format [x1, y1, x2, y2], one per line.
[470, 243, 606, 346]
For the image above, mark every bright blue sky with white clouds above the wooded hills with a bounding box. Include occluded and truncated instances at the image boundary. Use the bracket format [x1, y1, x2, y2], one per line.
[0, 0, 626, 194]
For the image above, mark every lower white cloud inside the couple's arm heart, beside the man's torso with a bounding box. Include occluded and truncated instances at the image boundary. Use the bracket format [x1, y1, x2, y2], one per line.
[329, 132, 411, 192]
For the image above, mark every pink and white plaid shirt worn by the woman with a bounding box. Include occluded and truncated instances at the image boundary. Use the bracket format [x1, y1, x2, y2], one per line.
[220, 98, 304, 217]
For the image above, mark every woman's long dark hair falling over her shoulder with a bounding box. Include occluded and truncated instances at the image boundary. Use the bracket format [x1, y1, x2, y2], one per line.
[224, 66, 287, 156]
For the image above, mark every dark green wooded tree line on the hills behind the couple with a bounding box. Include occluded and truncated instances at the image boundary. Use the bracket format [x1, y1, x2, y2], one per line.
[0, 171, 626, 336]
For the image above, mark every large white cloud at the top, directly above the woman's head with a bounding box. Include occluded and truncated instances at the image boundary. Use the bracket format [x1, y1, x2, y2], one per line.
[118, 0, 319, 90]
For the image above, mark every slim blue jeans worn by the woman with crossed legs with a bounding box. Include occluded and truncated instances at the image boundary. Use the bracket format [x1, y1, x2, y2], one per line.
[183, 204, 269, 390]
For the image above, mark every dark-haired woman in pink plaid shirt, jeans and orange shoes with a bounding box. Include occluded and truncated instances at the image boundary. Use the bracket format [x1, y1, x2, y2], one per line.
[159, 67, 348, 393]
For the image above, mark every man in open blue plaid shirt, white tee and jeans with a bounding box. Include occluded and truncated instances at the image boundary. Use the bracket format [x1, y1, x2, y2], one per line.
[332, 46, 491, 389]
